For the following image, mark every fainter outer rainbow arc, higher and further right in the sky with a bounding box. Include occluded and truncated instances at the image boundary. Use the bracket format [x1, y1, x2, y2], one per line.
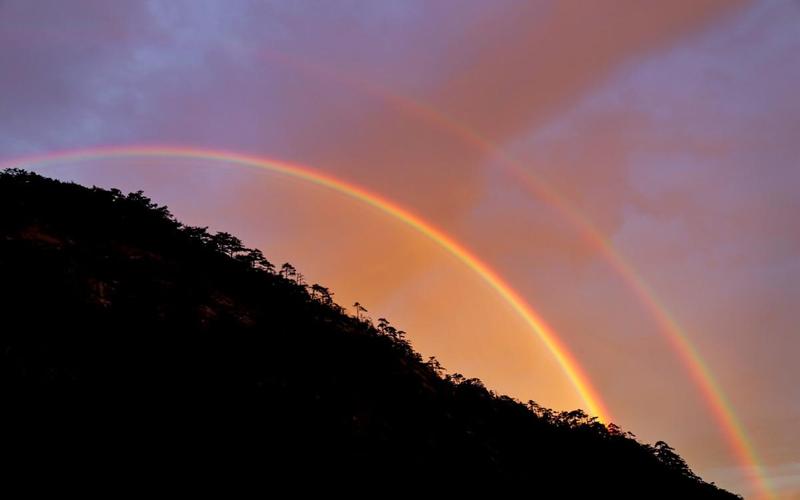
[263, 51, 775, 498]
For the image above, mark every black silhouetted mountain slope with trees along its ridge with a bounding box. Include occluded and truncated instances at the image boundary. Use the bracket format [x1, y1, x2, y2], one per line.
[0, 170, 736, 499]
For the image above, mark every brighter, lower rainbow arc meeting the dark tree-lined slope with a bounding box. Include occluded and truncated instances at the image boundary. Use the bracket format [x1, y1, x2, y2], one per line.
[0, 145, 611, 422]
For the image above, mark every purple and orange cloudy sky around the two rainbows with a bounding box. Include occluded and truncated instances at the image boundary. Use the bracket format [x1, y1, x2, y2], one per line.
[0, 0, 800, 499]
